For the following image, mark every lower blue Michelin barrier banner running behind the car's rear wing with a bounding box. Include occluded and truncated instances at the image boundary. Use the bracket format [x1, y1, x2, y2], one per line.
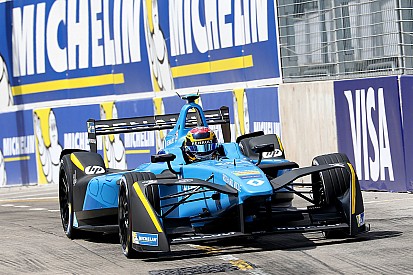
[0, 87, 280, 186]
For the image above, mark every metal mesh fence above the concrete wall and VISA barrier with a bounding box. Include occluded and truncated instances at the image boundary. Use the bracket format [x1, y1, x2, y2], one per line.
[278, 0, 413, 82]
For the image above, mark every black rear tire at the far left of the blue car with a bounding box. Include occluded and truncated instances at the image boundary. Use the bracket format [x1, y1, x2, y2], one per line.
[59, 155, 79, 239]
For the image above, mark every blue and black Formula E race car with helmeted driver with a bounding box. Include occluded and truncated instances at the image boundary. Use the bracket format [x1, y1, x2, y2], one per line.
[59, 95, 367, 257]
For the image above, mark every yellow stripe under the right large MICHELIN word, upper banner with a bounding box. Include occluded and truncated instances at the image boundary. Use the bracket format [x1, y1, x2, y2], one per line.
[171, 55, 254, 78]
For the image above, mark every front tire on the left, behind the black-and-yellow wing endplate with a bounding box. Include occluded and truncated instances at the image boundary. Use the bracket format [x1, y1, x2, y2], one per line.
[118, 172, 160, 258]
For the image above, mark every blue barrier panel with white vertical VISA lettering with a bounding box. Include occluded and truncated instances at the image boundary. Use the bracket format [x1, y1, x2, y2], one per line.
[334, 76, 406, 192]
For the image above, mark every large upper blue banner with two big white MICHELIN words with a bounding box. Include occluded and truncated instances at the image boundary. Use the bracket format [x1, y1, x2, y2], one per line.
[0, 0, 281, 107]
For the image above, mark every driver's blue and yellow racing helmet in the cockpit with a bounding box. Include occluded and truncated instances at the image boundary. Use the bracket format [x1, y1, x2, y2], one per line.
[183, 127, 218, 162]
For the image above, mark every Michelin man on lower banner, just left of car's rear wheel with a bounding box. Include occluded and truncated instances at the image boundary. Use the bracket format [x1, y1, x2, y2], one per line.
[33, 109, 62, 184]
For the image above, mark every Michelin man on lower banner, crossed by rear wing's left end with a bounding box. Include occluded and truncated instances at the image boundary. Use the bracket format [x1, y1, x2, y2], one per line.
[100, 102, 127, 169]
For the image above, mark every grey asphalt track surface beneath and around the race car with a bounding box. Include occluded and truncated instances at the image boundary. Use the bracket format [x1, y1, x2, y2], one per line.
[0, 185, 413, 275]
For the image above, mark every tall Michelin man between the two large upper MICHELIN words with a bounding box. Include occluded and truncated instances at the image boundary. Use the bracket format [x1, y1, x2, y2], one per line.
[143, 0, 174, 91]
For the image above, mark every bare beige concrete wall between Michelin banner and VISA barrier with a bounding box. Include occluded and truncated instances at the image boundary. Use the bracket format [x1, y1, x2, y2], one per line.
[279, 81, 338, 169]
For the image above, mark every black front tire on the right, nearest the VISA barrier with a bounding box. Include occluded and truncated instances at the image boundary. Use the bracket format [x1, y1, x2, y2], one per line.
[311, 153, 350, 206]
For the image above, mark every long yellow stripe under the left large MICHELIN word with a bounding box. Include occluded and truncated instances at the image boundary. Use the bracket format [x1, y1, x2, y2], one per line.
[12, 73, 125, 96]
